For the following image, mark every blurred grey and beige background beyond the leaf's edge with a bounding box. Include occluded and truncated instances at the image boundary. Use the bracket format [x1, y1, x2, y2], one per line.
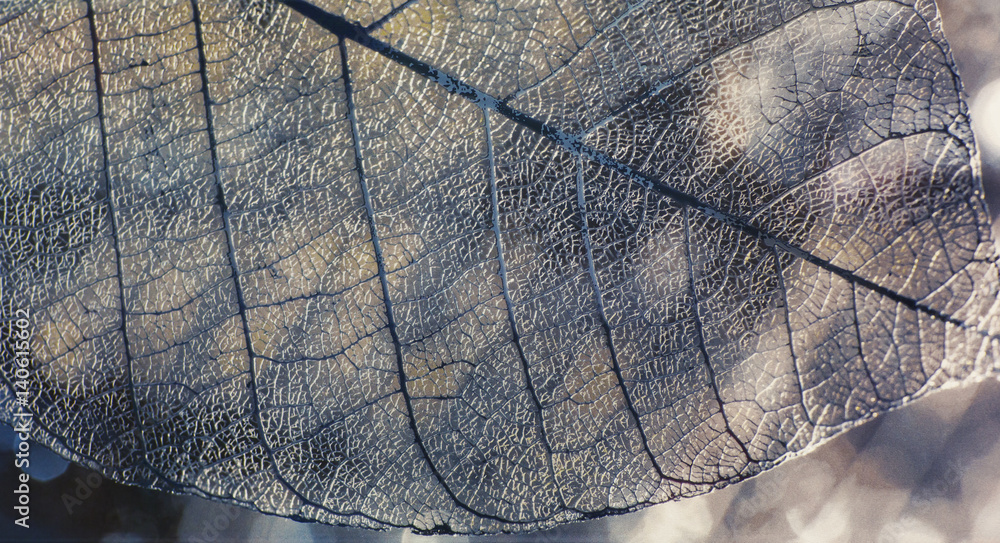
[0, 0, 1000, 543]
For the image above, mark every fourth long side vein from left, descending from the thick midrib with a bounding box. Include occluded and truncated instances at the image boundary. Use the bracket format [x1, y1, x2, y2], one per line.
[483, 109, 569, 507]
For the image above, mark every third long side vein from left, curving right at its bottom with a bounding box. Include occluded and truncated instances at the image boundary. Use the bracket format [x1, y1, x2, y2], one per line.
[337, 37, 517, 524]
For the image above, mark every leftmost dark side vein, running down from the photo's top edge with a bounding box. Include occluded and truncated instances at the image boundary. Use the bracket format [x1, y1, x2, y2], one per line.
[87, 0, 153, 478]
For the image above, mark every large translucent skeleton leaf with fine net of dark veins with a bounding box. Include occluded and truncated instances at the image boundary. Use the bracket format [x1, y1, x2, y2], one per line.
[0, 0, 1000, 533]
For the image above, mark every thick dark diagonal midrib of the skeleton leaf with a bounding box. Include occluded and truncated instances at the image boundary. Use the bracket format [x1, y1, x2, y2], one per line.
[280, 0, 1000, 348]
